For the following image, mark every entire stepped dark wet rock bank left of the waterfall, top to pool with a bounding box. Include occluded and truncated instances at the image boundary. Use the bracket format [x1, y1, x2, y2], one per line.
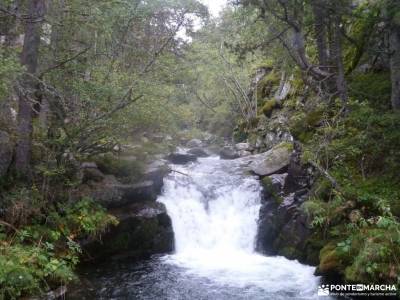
[77, 156, 174, 259]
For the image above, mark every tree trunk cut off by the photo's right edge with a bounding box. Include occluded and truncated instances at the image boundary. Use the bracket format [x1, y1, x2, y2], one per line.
[389, 24, 400, 110]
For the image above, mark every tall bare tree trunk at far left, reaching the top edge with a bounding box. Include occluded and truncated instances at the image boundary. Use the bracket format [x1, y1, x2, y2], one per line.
[15, 0, 45, 177]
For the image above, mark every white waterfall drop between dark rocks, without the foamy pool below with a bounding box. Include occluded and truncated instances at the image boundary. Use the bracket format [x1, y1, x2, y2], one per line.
[159, 157, 261, 254]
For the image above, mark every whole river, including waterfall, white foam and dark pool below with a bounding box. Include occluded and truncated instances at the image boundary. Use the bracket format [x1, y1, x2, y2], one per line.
[70, 157, 327, 300]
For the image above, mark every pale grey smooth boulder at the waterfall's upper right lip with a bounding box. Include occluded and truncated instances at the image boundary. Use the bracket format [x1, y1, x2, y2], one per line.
[249, 143, 293, 176]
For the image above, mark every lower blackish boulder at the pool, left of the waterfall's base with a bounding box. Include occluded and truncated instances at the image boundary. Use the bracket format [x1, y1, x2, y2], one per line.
[83, 202, 174, 259]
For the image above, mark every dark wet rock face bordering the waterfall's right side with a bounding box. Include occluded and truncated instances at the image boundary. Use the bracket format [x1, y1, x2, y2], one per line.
[257, 144, 323, 265]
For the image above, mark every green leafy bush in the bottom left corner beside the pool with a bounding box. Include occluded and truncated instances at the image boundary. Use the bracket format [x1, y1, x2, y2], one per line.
[0, 199, 117, 299]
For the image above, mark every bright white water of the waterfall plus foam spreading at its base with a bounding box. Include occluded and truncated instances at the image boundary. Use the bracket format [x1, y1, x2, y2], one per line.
[158, 157, 319, 299]
